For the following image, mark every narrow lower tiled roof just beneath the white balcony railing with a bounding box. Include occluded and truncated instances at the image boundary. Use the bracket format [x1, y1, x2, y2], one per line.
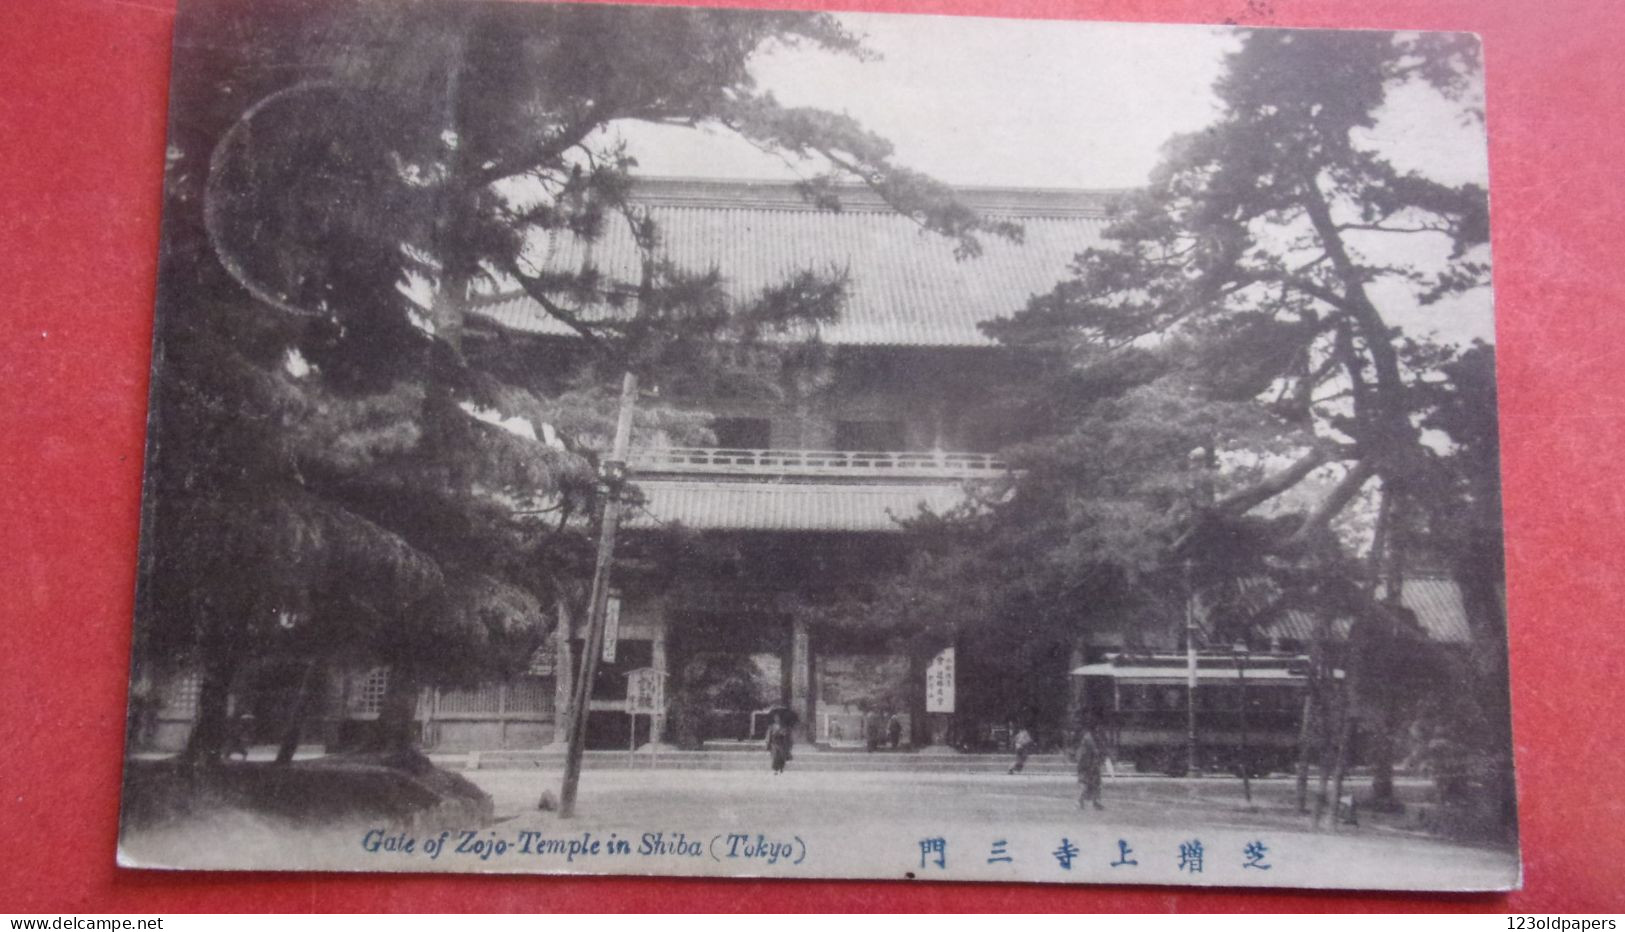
[627, 479, 964, 531]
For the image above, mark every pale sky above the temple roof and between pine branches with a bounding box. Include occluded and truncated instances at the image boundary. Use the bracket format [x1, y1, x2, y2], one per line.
[619, 13, 1495, 343]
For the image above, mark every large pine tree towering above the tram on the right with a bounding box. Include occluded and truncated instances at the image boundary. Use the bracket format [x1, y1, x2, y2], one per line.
[824, 31, 1510, 818]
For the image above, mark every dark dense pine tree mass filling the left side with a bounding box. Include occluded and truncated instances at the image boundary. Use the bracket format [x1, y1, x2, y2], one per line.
[138, 0, 1017, 762]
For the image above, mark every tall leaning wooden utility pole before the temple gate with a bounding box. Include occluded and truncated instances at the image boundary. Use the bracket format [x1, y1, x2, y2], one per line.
[559, 372, 637, 818]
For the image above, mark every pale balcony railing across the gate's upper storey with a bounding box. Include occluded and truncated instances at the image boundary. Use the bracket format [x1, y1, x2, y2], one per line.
[632, 447, 1006, 479]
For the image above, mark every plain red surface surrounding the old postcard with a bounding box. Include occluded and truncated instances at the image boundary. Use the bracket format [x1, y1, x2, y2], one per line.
[0, 0, 1625, 913]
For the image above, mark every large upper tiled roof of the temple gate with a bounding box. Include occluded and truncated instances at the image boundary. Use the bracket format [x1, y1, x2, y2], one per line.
[471, 180, 1112, 346]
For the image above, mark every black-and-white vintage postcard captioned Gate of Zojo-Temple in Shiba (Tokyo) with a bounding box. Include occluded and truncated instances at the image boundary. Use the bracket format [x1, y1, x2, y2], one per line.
[119, 0, 1519, 890]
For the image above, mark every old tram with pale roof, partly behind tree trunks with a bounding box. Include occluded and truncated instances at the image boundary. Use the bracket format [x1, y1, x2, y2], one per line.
[1073, 651, 1310, 776]
